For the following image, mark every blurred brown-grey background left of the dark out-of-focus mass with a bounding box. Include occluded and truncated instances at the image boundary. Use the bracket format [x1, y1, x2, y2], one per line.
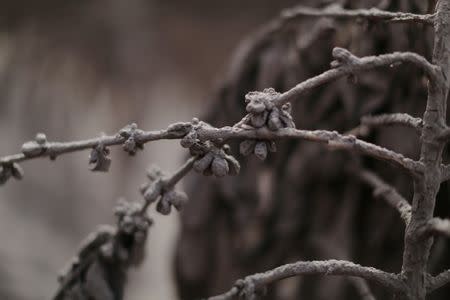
[0, 0, 295, 300]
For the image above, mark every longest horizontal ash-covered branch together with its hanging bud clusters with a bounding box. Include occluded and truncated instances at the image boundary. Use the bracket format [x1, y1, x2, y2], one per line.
[0, 115, 423, 182]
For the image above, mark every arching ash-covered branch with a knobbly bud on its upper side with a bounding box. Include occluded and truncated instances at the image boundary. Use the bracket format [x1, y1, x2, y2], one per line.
[274, 47, 442, 106]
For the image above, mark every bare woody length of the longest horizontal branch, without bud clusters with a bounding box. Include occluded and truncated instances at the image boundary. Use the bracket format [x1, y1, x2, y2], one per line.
[0, 123, 423, 185]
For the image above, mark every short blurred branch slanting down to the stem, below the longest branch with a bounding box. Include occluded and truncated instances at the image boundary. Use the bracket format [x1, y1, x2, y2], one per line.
[355, 170, 411, 225]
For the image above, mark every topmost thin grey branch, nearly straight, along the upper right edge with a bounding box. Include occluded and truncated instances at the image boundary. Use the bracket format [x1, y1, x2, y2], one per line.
[282, 5, 435, 25]
